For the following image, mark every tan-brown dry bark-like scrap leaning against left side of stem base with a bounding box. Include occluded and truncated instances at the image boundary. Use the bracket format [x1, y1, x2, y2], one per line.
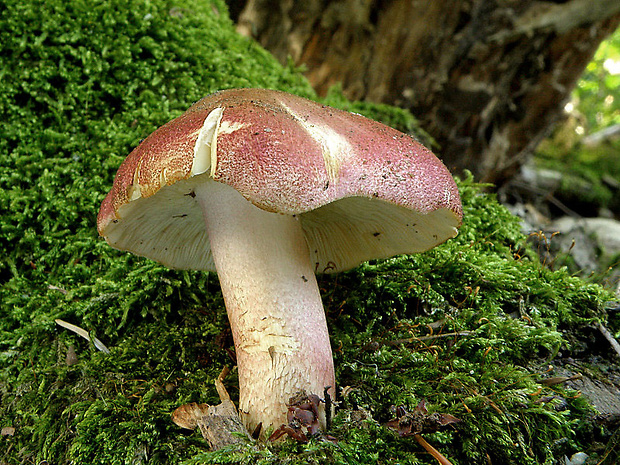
[172, 367, 251, 450]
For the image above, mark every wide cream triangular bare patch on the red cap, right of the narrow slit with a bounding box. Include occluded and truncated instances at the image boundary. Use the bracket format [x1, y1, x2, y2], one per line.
[280, 102, 353, 182]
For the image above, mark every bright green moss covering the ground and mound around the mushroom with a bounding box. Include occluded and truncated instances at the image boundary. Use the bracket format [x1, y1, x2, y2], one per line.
[0, 0, 620, 465]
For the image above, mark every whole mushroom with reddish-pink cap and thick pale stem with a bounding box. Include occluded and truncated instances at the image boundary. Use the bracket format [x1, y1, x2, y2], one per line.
[97, 89, 462, 431]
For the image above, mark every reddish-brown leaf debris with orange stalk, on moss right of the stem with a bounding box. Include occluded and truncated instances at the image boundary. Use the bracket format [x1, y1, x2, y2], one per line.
[386, 401, 461, 465]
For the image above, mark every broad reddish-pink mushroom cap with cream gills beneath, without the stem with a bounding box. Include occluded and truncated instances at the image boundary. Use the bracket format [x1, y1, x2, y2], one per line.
[97, 89, 462, 272]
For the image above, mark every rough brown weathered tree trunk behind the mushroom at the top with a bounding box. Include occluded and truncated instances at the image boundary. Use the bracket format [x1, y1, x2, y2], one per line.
[238, 0, 620, 184]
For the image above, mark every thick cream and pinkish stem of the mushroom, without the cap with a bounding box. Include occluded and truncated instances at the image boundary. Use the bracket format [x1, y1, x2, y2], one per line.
[195, 180, 335, 435]
